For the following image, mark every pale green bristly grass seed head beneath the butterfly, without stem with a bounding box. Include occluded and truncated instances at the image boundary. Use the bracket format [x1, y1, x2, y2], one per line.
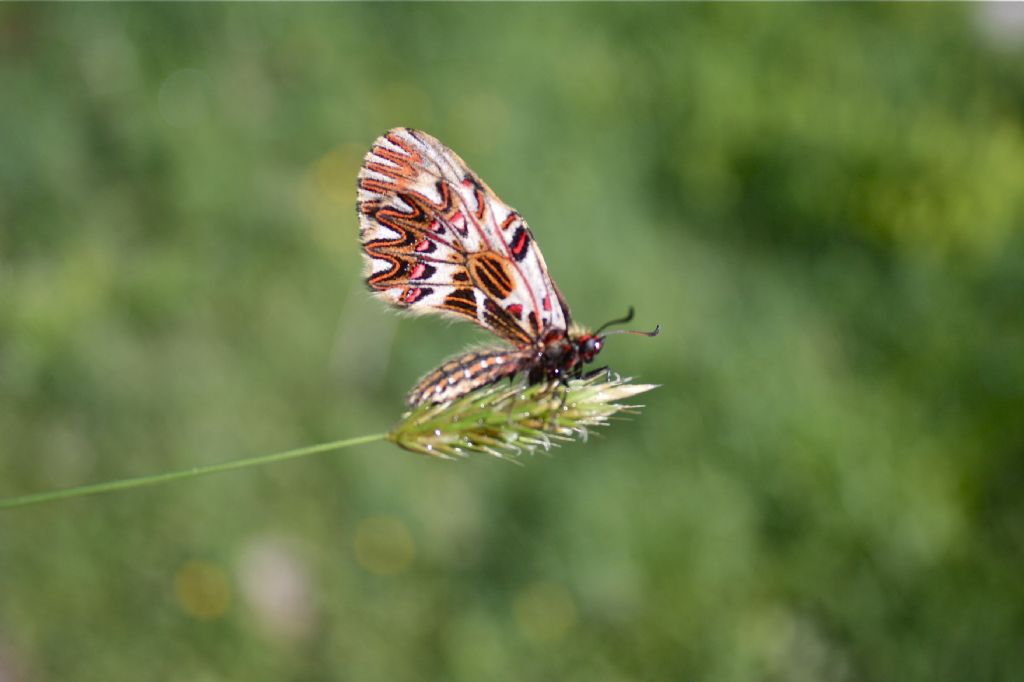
[387, 373, 656, 459]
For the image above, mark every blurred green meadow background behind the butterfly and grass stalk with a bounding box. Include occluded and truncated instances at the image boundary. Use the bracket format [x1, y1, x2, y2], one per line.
[0, 4, 1024, 682]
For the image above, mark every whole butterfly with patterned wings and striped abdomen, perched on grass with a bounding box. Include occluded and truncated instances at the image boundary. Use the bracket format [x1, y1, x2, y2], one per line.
[356, 128, 660, 406]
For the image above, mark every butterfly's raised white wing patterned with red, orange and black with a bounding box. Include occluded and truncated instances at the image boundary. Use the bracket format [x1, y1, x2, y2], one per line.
[358, 128, 569, 346]
